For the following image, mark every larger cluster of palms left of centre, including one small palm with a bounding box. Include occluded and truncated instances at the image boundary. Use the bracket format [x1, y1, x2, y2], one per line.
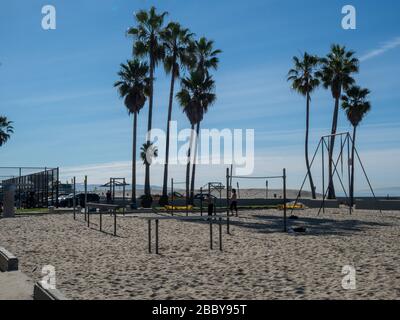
[114, 7, 221, 207]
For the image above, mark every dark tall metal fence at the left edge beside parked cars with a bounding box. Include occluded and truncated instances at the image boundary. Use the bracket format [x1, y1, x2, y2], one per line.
[0, 167, 60, 208]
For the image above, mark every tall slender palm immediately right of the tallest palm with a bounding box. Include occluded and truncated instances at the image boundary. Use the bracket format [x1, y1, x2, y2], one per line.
[160, 22, 193, 205]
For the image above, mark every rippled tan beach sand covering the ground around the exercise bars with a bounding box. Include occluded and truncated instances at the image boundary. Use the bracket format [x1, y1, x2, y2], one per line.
[0, 209, 400, 299]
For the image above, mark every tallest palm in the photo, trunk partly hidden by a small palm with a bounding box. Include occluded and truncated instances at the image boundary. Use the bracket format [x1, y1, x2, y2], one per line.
[127, 7, 167, 207]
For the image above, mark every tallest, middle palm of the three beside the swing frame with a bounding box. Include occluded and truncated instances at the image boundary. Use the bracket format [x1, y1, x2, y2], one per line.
[318, 44, 359, 199]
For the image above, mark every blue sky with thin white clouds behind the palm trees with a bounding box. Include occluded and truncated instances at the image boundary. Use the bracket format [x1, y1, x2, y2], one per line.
[0, 0, 400, 190]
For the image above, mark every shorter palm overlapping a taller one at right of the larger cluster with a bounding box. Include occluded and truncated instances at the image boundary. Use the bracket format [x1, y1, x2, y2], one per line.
[176, 71, 216, 202]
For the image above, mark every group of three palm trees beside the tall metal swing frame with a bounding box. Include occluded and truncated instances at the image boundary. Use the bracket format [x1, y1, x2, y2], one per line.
[288, 44, 371, 199]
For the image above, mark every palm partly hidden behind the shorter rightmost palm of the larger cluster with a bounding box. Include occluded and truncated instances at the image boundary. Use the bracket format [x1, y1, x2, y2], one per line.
[190, 37, 222, 203]
